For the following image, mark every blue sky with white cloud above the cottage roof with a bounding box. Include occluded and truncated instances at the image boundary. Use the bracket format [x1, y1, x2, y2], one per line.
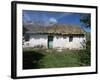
[22, 10, 90, 32]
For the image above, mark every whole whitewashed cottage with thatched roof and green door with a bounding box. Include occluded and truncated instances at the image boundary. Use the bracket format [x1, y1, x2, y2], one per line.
[23, 24, 86, 49]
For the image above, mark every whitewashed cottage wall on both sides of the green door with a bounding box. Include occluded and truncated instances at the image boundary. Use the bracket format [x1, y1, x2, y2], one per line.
[25, 34, 85, 49]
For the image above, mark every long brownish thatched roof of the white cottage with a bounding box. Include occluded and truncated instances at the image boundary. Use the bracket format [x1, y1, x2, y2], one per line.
[24, 24, 84, 34]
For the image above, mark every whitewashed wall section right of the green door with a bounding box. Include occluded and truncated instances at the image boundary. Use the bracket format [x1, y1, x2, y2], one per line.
[53, 36, 85, 49]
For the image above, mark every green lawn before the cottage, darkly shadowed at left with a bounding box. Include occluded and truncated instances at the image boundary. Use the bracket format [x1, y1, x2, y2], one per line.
[23, 49, 90, 69]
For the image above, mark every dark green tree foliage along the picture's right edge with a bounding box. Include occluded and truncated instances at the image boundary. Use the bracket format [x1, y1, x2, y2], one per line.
[79, 14, 91, 66]
